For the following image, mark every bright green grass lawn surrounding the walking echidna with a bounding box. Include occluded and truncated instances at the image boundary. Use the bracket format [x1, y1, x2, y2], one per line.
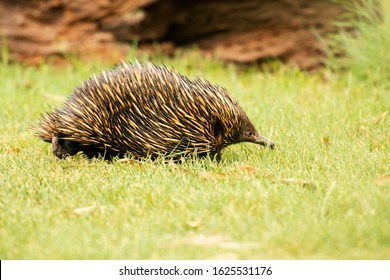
[0, 2, 390, 259]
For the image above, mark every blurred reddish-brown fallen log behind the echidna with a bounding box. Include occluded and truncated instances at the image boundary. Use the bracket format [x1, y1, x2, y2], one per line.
[0, 0, 354, 69]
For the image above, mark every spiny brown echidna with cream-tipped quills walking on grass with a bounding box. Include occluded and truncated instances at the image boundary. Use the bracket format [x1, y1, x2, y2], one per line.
[34, 63, 275, 160]
